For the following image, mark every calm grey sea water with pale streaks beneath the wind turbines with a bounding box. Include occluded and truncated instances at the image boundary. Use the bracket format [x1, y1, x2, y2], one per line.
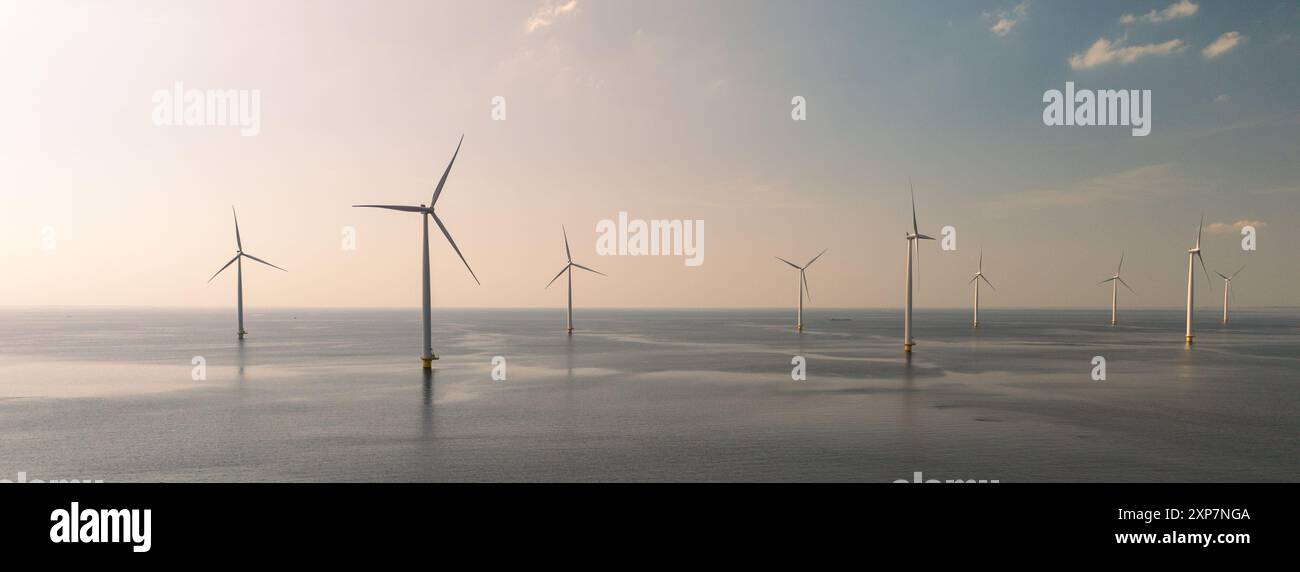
[0, 309, 1300, 482]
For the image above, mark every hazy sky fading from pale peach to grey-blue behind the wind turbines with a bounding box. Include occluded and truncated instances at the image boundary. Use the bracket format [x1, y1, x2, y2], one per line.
[0, 0, 1300, 308]
